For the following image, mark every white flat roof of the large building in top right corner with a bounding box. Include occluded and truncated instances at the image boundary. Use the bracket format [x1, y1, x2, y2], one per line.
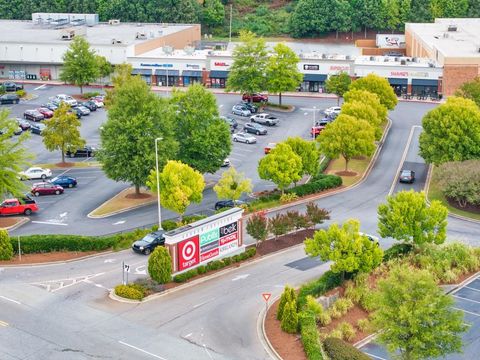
[406, 18, 480, 58]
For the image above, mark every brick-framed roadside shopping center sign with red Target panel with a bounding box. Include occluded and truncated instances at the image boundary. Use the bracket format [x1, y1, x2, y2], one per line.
[165, 208, 245, 273]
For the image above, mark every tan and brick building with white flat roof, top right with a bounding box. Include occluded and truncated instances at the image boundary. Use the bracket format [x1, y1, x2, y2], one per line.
[405, 18, 480, 96]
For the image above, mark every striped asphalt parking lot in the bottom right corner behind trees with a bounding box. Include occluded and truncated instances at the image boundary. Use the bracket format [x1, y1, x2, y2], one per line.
[360, 274, 480, 360]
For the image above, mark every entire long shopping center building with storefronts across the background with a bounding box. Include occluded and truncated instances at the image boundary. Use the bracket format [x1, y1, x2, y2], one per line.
[0, 13, 480, 97]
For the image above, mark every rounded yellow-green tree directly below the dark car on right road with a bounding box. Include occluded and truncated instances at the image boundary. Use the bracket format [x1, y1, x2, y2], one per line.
[378, 190, 448, 246]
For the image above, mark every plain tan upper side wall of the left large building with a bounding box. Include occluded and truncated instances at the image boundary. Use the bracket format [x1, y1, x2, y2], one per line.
[134, 24, 201, 55]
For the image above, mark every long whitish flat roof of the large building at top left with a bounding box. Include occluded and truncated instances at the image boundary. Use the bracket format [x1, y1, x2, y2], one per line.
[0, 20, 193, 46]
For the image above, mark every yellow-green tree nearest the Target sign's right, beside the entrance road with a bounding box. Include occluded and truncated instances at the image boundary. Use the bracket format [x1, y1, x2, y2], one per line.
[304, 219, 383, 277]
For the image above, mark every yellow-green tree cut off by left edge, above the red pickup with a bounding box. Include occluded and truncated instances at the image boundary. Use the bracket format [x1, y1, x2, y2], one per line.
[0, 109, 33, 198]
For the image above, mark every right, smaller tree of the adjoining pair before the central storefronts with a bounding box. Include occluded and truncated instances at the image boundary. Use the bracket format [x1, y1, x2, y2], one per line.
[266, 43, 303, 105]
